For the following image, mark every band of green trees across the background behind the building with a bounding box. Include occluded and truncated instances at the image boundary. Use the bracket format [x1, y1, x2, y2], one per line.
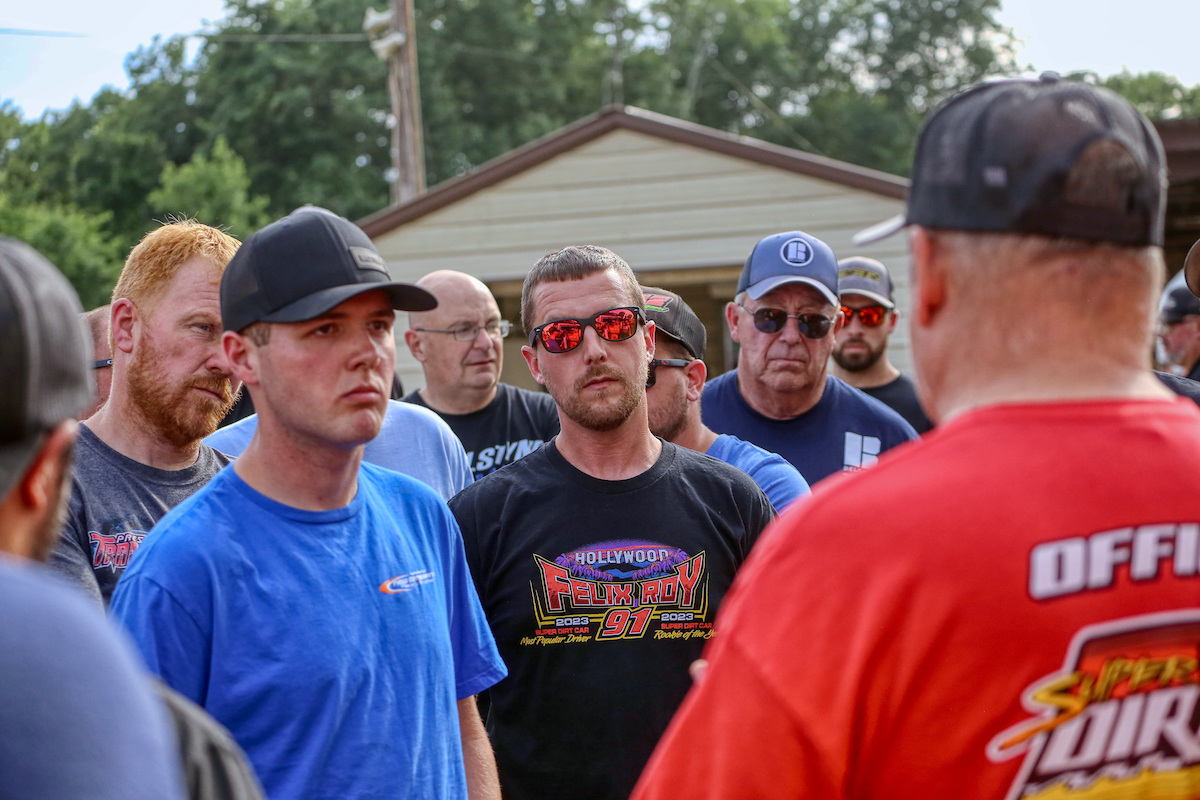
[0, 0, 1200, 300]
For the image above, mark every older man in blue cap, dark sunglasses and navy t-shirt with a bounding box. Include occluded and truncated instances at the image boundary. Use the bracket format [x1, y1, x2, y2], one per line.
[702, 230, 917, 485]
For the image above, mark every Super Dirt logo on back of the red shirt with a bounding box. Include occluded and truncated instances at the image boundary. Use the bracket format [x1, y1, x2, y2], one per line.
[988, 609, 1200, 800]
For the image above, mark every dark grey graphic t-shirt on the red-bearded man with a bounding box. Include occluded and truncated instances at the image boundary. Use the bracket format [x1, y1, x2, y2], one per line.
[49, 425, 233, 607]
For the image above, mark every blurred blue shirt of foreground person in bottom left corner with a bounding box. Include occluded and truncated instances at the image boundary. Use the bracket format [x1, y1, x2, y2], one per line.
[0, 558, 185, 800]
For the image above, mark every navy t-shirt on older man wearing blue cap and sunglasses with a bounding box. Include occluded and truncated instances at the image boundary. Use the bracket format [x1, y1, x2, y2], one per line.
[700, 369, 917, 486]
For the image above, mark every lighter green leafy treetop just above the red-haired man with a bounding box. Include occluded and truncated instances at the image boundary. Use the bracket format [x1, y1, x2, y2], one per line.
[149, 137, 271, 239]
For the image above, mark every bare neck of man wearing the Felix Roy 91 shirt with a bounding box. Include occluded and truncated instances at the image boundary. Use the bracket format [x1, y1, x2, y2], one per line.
[554, 399, 662, 481]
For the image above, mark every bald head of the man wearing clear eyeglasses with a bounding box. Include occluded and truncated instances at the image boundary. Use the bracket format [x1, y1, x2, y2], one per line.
[404, 270, 506, 414]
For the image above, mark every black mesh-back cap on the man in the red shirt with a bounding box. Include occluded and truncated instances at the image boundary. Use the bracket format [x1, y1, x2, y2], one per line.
[854, 73, 1166, 247]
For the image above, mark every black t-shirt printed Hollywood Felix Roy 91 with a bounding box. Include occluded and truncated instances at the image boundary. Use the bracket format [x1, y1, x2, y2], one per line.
[450, 441, 773, 800]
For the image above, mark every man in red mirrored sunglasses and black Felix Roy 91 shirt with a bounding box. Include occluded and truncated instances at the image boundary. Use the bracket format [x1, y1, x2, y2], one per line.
[450, 246, 773, 800]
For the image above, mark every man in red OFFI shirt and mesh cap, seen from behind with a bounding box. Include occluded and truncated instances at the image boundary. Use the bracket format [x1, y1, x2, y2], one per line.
[635, 77, 1200, 800]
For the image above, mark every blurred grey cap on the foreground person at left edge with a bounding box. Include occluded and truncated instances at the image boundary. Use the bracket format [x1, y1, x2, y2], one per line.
[0, 236, 94, 497]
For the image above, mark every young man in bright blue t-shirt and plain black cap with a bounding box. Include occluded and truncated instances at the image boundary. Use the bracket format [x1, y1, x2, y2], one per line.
[113, 206, 505, 800]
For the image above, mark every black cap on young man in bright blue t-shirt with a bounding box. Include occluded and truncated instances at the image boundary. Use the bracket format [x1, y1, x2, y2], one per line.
[221, 205, 438, 331]
